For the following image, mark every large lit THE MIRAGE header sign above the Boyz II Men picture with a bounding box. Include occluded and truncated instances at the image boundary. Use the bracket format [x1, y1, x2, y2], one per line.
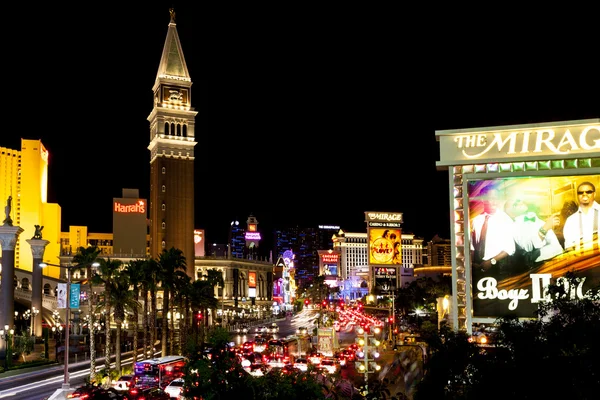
[436, 119, 600, 165]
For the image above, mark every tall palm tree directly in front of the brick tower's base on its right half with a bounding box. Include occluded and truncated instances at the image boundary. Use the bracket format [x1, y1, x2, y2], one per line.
[158, 247, 186, 356]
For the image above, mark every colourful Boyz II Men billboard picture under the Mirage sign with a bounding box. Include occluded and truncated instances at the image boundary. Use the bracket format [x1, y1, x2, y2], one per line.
[465, 175, 600, 318]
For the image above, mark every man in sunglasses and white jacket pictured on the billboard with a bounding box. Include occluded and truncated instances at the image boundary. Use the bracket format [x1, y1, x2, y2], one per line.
[563, 182, 600, 250]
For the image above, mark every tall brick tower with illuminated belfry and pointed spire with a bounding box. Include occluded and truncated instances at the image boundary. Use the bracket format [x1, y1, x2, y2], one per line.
[148, 9, 197, 279]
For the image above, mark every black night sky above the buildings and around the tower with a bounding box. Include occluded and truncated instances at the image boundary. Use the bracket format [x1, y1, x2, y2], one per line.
[0, 1, 600, 248]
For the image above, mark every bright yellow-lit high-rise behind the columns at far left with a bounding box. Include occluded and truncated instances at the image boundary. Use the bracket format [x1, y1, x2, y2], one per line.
[0, 139, 61, 278]
